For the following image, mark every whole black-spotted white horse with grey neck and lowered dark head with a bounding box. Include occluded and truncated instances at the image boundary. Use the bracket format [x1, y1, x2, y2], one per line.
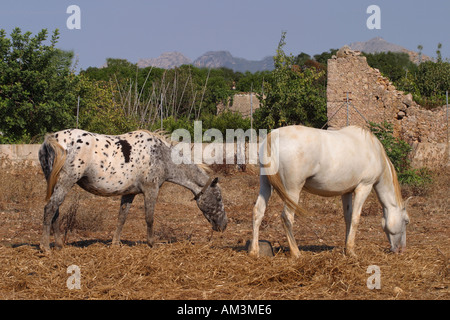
[39, 129, 227, 251]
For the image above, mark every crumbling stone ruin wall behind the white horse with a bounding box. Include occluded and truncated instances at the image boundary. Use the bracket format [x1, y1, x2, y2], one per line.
[327, 47, 450, 167]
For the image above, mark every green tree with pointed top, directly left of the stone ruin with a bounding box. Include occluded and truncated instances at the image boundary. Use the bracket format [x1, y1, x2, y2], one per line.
[254, 32, 327, 129]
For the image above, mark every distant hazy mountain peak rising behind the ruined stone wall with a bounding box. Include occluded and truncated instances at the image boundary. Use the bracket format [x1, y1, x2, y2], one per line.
[348, 37, 432, 63]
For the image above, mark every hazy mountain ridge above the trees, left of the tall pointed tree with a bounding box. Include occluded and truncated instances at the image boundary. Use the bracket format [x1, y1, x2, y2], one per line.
[137, 51, 274, 73]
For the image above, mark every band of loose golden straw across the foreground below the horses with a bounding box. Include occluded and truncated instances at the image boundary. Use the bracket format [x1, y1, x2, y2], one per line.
[0, 242, 450, 299]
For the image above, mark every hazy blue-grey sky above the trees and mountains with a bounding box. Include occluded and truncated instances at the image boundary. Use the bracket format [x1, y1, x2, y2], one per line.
[0, 0, 450, 69]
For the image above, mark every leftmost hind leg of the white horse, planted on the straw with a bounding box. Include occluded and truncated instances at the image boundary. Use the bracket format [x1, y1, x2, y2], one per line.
[249, 175, 272, 257]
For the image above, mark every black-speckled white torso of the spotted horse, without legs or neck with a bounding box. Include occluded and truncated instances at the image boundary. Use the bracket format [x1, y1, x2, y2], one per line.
[48, 129, 170, 196]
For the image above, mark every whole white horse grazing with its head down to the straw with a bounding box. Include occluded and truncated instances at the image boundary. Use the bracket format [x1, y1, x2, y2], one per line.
[250, 126, 409, 257]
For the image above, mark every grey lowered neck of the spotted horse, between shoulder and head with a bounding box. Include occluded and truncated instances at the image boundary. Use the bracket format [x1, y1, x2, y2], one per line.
[167, 163, 209, 194]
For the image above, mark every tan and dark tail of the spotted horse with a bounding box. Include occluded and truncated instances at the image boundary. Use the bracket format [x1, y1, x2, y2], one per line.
[39, 135, 67, 201]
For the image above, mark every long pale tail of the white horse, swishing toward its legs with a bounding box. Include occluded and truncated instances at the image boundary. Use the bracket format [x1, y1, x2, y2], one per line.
[260, 133, 308, 215]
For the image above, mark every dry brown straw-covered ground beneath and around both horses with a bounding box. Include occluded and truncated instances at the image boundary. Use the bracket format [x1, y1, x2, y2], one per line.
[0, 164, 450, 300]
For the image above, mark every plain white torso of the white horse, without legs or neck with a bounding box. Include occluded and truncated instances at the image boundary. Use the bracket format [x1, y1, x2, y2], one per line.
[268, 126, 383, 196]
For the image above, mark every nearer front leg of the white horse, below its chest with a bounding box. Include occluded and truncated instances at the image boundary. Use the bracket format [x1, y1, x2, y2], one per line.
[344, 185, 372, 256]
